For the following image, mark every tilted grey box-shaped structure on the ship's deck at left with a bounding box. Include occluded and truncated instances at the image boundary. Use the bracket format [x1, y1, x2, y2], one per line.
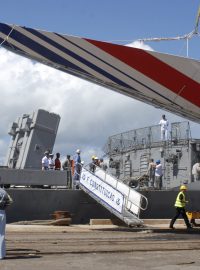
[5, 109, 60, 169]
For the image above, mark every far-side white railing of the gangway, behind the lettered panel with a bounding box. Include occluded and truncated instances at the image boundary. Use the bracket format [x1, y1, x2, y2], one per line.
[84, 164, 148, 216]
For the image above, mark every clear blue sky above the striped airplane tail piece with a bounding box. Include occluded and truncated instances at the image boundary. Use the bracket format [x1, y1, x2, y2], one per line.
[0, 0, 200, 58]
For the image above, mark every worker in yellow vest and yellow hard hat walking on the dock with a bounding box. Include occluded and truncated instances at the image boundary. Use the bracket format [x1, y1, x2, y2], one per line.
[169, 185, 192, 229]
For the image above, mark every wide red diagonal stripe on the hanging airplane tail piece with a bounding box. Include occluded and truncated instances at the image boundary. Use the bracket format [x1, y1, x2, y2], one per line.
[85, 39, 200, 107]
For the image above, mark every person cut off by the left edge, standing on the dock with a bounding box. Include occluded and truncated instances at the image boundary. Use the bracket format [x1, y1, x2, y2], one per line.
[0, 188, 12, 260]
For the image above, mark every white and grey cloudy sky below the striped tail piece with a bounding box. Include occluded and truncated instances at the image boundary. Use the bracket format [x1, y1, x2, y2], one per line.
[0, 46, 198, 164]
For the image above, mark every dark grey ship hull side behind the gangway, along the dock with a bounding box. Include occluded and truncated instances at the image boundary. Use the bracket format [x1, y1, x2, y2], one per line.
[7, 187, 200, 224]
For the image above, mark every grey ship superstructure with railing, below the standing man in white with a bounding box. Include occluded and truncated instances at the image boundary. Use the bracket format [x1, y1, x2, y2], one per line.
[104, 122, 200, 189]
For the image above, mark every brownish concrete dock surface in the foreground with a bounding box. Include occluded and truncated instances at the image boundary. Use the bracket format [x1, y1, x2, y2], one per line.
[0, 220, 200, 270]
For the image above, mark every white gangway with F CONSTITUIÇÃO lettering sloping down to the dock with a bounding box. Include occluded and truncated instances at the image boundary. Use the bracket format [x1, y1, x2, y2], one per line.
[80, 166, 148, 226]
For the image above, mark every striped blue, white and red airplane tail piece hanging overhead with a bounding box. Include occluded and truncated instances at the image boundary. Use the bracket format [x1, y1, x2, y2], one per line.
[0, 23, 200, 122]
